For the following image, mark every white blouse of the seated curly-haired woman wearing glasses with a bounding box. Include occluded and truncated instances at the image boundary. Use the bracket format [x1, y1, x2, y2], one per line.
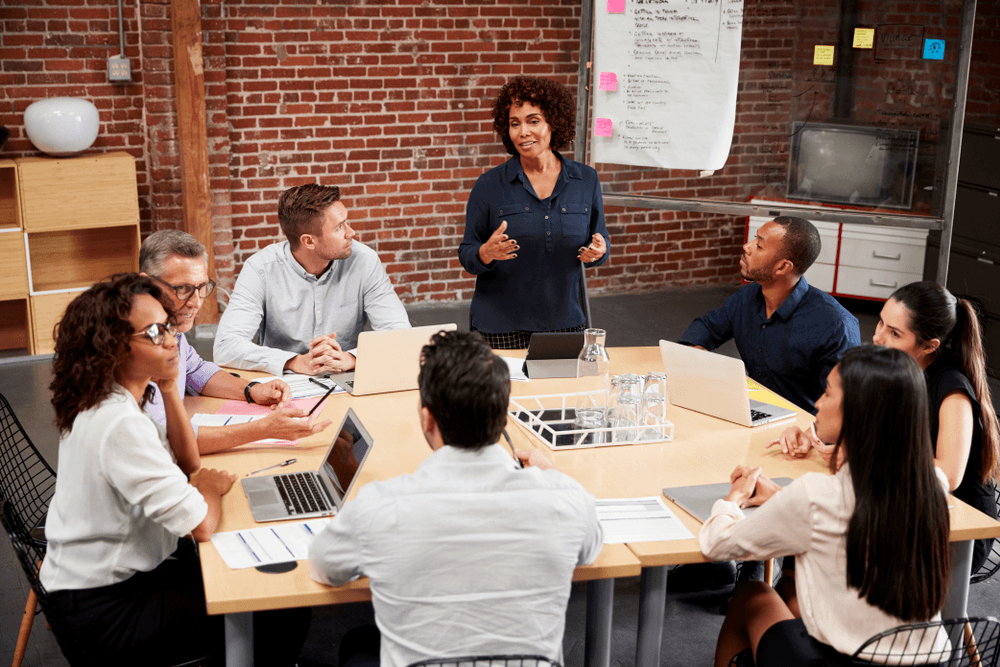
[40, 385, 208, 591]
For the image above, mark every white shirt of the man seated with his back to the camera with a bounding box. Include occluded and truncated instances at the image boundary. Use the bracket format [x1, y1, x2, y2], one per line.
[309, 445, 603, 667]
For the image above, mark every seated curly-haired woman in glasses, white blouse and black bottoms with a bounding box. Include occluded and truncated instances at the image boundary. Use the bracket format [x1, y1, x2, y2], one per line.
[40, 273, 308, 665]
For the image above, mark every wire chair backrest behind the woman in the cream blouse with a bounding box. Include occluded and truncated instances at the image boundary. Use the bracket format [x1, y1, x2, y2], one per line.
[852, 617, 1000, 667]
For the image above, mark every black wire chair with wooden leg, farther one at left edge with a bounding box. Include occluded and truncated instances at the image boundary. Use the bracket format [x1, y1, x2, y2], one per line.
[0, 394, 56, 667]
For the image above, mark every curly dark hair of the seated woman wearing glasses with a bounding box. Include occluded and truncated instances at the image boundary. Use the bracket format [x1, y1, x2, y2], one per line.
[49, 273, 174, 434]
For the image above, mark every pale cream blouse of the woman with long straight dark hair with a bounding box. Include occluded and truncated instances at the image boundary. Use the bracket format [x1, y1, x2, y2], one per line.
[698, 465, 950, 655]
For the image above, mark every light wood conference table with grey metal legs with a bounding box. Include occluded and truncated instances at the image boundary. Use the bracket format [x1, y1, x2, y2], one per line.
[193, 347, 1000, 667]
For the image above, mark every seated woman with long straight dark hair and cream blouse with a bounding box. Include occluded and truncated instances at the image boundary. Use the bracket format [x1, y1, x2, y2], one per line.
[699, 345, 949, 667]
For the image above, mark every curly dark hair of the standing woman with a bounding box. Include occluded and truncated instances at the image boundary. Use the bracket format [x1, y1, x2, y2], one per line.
[493, 76, 576, 155]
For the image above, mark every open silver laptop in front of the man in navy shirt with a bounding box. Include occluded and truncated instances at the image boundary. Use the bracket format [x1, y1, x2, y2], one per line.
[660, 340, 795, 426]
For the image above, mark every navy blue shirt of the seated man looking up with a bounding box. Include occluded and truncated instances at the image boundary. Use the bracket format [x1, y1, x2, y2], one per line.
[680, 277, 861, 413]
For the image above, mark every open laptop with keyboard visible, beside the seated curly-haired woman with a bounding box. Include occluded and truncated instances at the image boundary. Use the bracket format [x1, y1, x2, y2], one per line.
[240, 408, 372, 522]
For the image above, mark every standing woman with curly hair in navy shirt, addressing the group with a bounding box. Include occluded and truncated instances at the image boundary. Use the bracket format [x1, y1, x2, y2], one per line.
[458, 76, 608, 349]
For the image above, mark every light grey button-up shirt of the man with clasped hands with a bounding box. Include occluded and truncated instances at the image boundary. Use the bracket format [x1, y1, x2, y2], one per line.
[213, 241, 410, 375]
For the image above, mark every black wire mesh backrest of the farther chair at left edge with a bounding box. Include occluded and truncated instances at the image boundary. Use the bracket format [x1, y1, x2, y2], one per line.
[0, 394, 56, 533]
